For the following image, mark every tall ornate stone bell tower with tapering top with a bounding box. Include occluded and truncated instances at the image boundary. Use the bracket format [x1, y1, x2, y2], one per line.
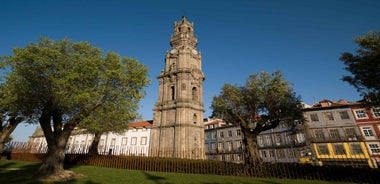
[150, 17, 205, 159]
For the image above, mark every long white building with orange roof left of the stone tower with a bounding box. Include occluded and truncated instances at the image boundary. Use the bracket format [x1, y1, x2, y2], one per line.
[28, 121, 152, 156]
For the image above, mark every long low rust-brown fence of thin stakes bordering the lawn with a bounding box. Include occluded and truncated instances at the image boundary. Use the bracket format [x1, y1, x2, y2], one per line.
[3, 142, 380, 183]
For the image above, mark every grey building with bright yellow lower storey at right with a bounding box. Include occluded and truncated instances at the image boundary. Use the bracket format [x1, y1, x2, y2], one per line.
[304, 100, 373, 167]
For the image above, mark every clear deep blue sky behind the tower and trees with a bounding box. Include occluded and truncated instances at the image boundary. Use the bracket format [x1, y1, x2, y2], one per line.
[0, 0, 380, 141]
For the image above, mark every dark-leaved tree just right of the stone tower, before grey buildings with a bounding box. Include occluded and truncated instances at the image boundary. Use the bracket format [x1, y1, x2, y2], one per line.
[211, 71, 302, 163]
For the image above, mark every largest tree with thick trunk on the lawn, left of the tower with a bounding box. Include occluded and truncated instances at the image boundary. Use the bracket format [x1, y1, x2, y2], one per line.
[4, 38, 149, 179]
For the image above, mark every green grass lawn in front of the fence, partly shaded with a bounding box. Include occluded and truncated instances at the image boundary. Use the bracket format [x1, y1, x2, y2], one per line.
[0, 160, 350, 184]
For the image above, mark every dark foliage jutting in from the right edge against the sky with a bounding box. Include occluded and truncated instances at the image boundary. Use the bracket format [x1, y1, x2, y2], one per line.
[340, 31, 380, 105]
